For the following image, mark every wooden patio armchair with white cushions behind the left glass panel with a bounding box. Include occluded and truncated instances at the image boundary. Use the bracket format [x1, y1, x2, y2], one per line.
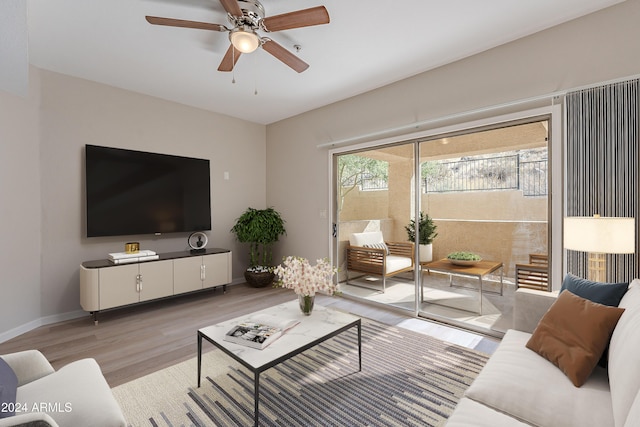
[346, 231, 414, 293]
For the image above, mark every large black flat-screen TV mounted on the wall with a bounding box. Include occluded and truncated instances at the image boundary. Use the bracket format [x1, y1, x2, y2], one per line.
[85, 145, 211, 237]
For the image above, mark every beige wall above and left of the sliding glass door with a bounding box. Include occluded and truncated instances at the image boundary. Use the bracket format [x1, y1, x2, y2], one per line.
[267, 0, 640, 280]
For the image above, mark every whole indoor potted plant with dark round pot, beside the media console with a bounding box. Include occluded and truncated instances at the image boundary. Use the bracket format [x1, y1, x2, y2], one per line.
[231, 208, 287, 287]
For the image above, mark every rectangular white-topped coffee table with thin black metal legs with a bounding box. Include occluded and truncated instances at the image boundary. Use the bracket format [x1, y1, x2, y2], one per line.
[198, 300, 362, 426]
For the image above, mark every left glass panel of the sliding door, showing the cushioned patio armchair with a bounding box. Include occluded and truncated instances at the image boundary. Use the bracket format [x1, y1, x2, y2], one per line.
[334, 143, 415, 311]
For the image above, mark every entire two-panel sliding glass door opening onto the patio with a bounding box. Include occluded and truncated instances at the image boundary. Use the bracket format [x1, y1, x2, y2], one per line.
[333, 116, 550, 335]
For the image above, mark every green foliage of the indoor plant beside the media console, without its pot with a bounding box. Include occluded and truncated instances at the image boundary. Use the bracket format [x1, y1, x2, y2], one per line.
[231, 208, 287, 268]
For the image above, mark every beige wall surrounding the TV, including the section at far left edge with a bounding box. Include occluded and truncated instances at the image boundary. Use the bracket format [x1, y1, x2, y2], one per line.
[0, 69, 266, 338]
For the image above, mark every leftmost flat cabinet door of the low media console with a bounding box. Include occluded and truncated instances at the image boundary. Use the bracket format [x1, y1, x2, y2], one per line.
[100, 264, 140, 310]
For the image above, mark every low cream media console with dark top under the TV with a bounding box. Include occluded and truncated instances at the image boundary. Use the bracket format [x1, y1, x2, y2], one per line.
[80, 248, 232, 324]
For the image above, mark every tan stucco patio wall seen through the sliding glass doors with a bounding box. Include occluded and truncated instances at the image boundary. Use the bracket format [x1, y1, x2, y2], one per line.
[339, 190, 549, 278]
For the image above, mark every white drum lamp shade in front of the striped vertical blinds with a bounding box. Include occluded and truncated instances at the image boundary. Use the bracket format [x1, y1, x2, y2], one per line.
[564, 215, 635, 254]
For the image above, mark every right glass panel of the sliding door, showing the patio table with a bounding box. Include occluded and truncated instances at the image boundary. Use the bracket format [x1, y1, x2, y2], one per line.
[420, 118, 549, 334]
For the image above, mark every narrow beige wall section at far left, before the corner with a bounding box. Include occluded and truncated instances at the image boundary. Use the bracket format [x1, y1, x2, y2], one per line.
[0, 67, 42, 334]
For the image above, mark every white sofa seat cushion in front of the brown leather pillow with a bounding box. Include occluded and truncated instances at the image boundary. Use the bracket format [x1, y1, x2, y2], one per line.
[465, 329, 614, 427]
